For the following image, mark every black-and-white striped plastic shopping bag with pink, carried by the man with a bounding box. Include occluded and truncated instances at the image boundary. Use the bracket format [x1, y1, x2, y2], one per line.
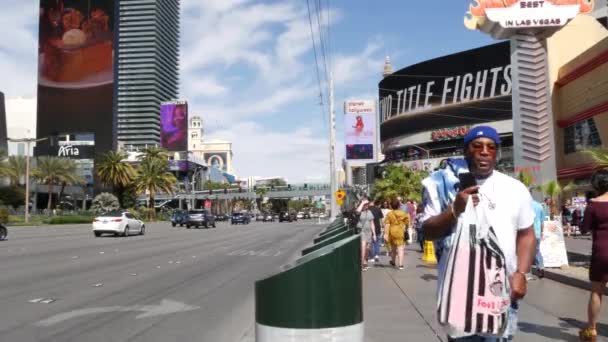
[437, 198, 511, 338]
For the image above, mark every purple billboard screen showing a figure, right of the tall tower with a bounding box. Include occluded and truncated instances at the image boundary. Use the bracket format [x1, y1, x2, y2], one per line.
[160, 101, 188, 151]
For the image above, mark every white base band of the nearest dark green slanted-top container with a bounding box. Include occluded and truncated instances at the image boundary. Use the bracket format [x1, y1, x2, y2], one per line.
[255, 322, 365, 342]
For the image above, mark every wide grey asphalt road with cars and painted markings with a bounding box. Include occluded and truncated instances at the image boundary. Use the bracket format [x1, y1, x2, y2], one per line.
[0, 221, 323, 342]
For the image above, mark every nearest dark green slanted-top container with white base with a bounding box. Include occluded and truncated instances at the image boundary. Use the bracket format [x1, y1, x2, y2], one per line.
[255, 234, 364, 342]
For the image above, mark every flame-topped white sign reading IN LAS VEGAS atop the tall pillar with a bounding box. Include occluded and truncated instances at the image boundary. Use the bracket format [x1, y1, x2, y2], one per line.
[464, 0, 595, 38]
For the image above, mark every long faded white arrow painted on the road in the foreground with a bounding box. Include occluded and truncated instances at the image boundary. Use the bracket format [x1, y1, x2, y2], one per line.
[34, 299, 200, 327]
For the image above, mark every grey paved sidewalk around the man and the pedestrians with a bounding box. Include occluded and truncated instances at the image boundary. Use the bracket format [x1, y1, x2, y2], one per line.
[363, 246, 608, 342]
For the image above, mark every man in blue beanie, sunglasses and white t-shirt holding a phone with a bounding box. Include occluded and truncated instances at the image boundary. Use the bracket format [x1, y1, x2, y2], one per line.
[422, 126, 536, 342]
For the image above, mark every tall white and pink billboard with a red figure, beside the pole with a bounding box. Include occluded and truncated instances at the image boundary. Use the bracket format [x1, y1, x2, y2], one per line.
[344, 101, 376, 160]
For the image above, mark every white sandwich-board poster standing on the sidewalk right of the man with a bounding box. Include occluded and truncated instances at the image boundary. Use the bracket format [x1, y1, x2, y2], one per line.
[540, 221, 568, 267]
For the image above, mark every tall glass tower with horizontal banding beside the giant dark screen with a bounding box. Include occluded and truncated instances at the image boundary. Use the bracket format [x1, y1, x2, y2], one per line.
[115, 0, 180, 149]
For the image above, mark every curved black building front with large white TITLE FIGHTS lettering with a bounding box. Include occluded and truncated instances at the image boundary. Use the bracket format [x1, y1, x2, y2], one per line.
[379, 42, 513, 172]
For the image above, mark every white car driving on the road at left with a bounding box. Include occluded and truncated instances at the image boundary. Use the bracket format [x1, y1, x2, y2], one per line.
[93, 211, 146, 237]
